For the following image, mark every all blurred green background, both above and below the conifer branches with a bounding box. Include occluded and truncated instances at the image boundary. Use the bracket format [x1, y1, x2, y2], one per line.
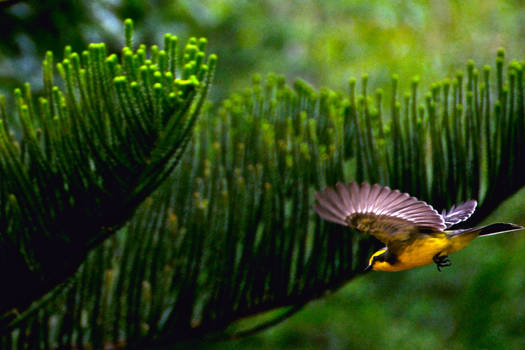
[0, 0, 525, 349]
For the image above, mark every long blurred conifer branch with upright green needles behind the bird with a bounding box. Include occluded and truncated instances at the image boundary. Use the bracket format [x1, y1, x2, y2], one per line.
[4, 51, 525, 349]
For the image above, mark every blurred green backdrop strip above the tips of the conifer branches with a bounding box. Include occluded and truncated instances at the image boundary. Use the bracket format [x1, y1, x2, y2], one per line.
[0, 0, 525, 100]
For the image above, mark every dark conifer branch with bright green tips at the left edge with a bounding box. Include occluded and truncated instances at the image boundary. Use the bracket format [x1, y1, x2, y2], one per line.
[0, 20, 216, 320]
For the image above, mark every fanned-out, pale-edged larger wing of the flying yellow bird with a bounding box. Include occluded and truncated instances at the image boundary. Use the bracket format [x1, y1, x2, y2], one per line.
[314, 182, 445, 245]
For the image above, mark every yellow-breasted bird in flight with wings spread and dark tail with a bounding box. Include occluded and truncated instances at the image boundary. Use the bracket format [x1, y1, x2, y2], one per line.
[314, 182, 523, 271]
